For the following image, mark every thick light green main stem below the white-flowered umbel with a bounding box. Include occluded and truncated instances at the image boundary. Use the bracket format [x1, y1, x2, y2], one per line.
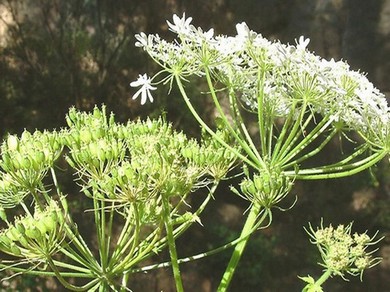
[217, 204, 268, 292]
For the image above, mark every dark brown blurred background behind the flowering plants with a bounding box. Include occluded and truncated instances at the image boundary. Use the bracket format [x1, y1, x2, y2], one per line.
[0, 0, 390, 292]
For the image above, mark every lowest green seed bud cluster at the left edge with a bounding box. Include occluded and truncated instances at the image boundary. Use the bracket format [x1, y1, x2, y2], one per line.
[0, 200, 65, 260]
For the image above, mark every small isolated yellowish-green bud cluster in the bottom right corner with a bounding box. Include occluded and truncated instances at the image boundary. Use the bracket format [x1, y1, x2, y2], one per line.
[306, 223, 379, 278]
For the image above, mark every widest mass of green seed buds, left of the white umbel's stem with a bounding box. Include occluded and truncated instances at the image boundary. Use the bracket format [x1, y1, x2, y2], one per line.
[64, 107, 235, 226]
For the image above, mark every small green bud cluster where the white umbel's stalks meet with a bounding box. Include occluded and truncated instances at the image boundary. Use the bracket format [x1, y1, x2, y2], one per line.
[233, 169, 293, 209]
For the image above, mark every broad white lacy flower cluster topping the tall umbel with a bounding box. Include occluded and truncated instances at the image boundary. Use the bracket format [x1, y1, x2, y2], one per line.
[136, 15, 390, 147]
